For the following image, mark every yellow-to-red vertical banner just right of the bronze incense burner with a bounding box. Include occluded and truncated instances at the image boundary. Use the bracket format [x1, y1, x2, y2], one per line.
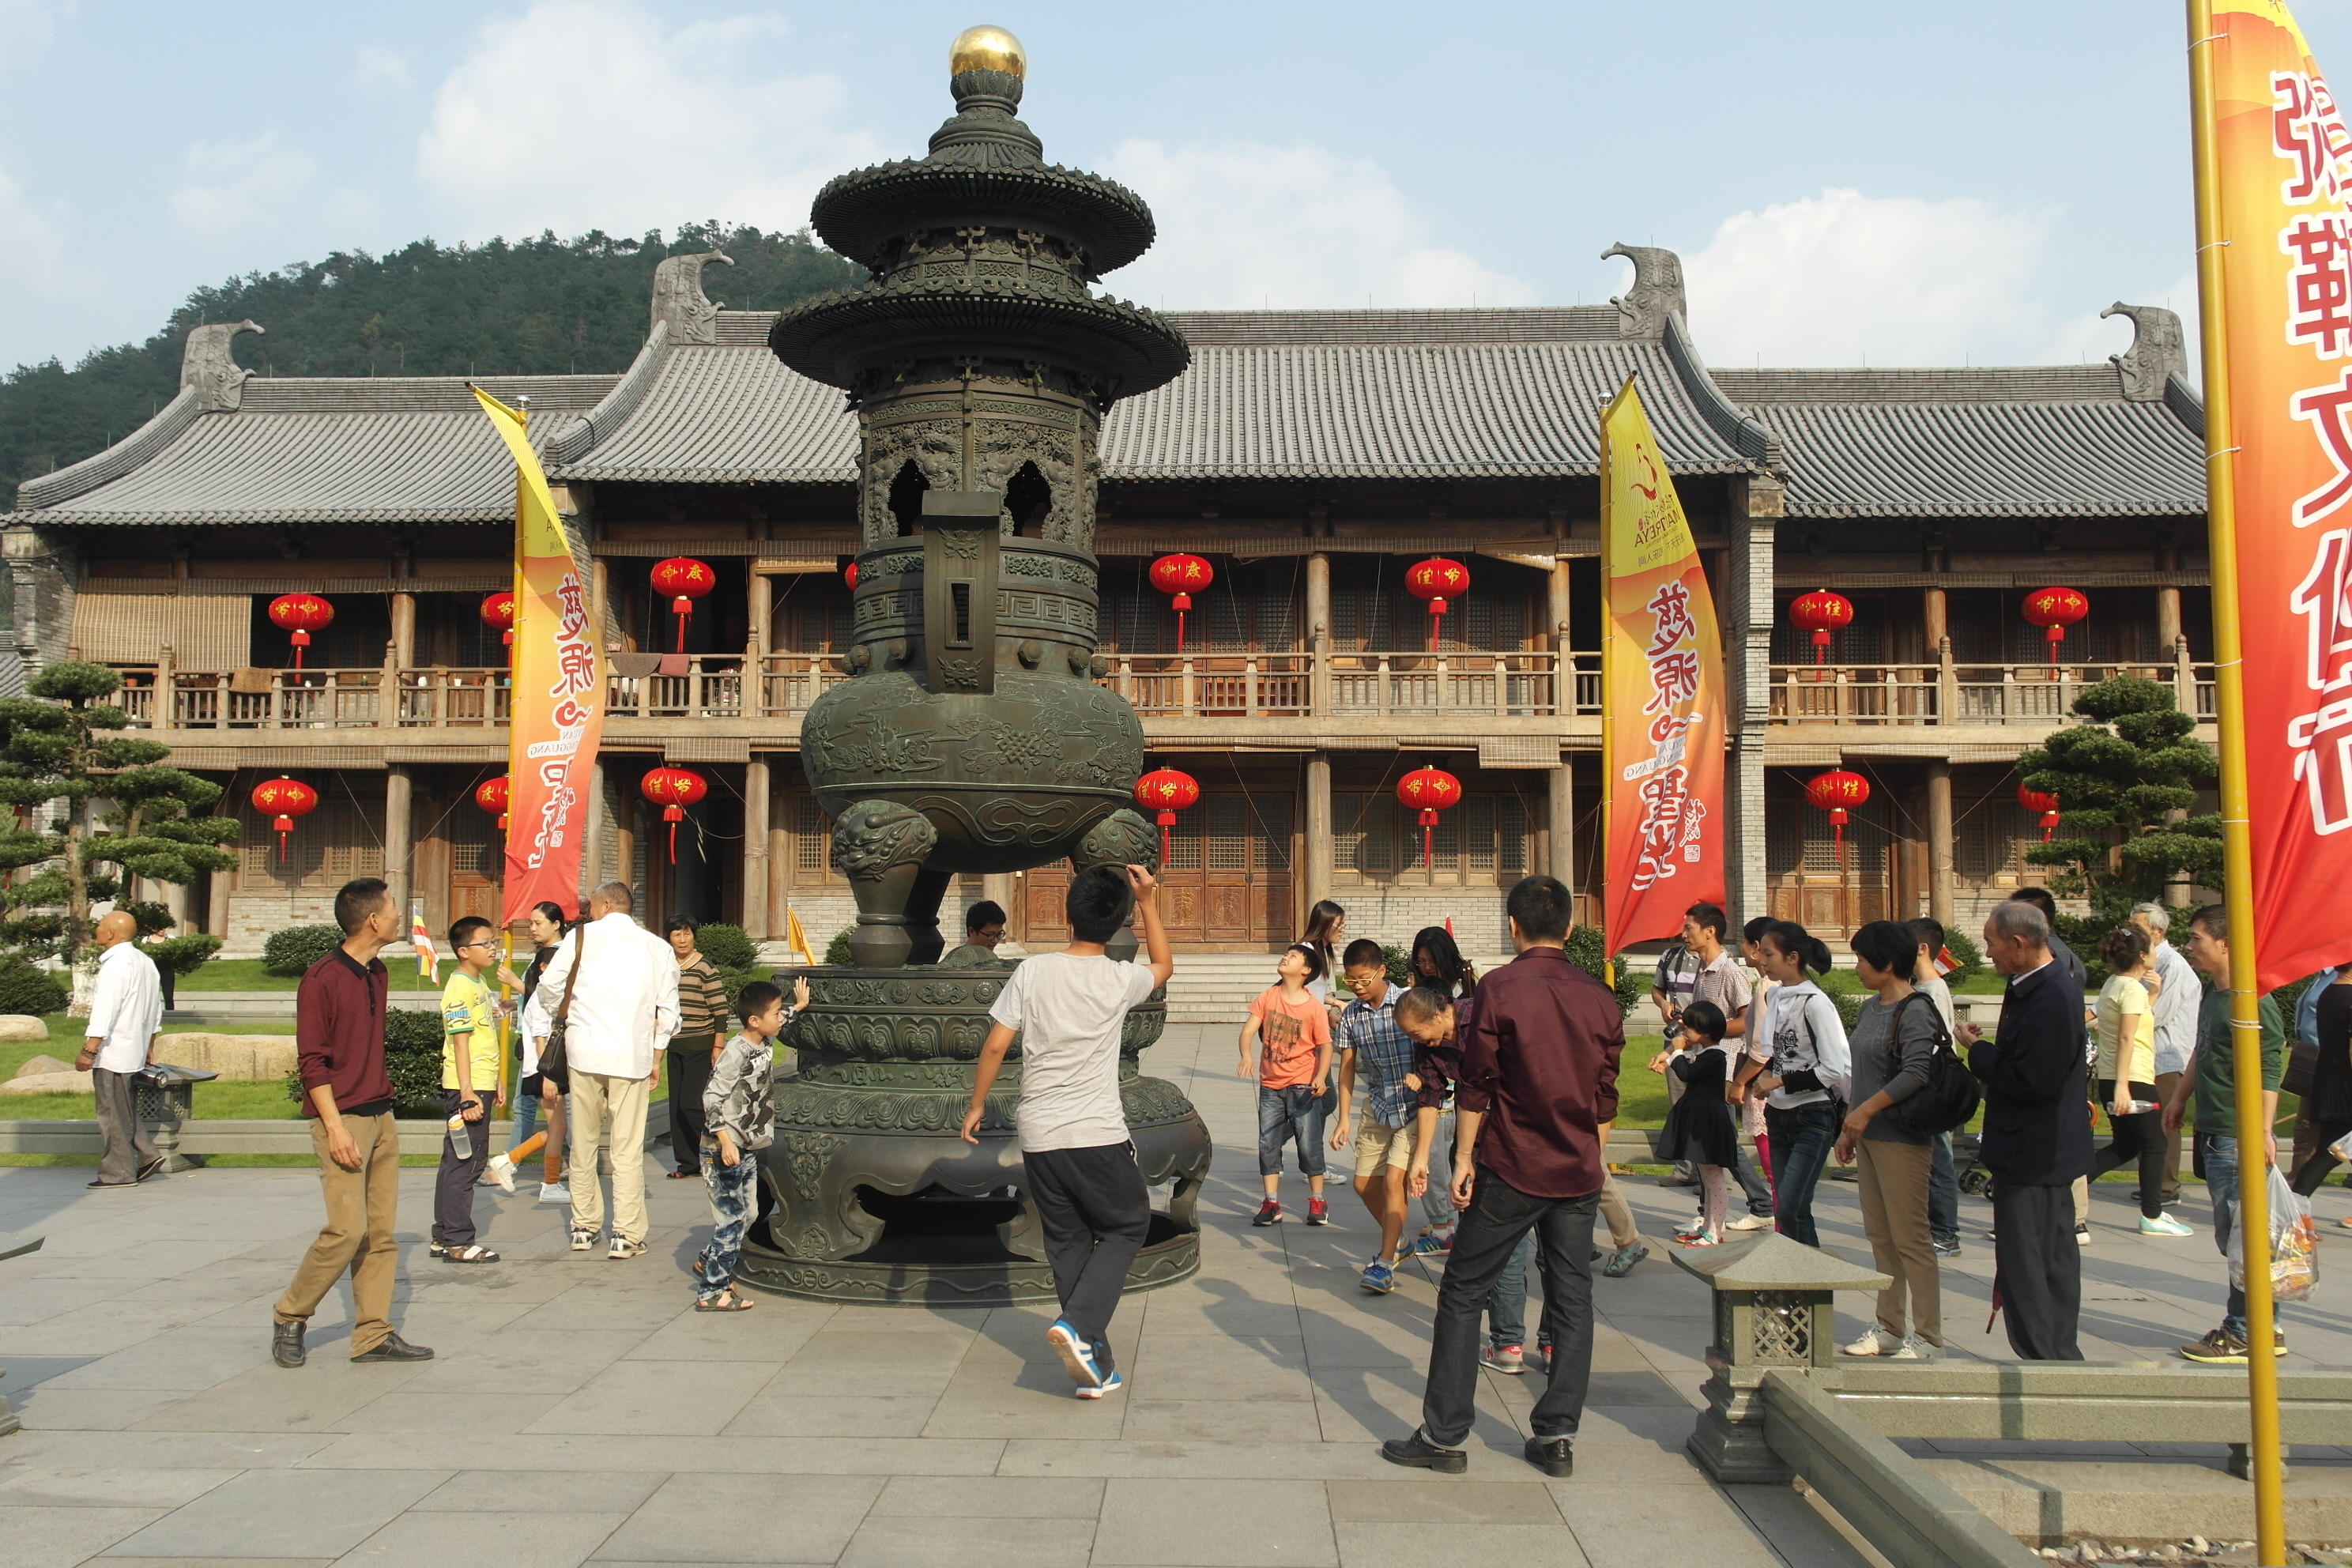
[1602, 379, 1726, 955]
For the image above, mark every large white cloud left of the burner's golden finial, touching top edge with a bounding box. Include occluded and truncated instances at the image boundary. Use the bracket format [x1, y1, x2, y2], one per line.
[416, 0, 880, 237]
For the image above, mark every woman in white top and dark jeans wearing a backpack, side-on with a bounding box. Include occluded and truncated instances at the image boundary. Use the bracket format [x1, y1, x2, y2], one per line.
[1750, 919, 1849, 1246]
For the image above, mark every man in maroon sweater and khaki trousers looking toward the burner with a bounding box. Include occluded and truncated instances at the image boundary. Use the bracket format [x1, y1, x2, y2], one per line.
[270, 876, 433, 1366]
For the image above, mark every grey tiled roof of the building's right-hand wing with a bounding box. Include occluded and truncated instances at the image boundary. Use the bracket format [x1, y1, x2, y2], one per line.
[1715, 364, 2204, 517]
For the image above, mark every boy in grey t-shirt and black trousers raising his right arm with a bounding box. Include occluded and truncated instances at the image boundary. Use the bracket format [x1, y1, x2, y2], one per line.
[962, 865, 1176, 1399]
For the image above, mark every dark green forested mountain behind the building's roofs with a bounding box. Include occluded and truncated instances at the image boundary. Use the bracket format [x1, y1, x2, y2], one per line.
[0, 224, 865, 501]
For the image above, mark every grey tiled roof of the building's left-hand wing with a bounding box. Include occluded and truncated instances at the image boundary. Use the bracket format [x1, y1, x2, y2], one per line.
[19, 376, 616, 526]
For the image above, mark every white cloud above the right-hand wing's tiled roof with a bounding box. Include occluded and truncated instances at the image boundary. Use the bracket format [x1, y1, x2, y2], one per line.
[1684, 188, 2060, 364]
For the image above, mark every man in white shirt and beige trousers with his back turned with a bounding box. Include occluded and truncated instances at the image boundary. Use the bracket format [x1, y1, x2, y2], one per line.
[522, 881, 677, 1257]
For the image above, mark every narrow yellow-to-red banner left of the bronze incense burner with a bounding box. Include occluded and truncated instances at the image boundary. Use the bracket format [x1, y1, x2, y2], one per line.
[473, 388, 605, 926]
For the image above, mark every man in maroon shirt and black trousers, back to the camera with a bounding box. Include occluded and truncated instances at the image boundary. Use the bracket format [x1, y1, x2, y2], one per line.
[1381, 876, 1625, 1476]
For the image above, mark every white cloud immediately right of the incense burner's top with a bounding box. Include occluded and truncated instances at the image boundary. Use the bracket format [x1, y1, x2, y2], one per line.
[1103, 141, 1533, 311]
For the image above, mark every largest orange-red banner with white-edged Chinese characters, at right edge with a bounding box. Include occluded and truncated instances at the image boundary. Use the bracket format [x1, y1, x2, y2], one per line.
[2204, 0, 2352, 989]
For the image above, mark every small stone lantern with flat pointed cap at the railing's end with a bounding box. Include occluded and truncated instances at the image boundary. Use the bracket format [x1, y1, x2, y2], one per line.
[1675, 1232, 1891, 1483]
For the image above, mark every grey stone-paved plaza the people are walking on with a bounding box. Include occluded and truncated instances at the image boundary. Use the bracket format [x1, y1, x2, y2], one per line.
[0, 1025, 2352, 1568]
